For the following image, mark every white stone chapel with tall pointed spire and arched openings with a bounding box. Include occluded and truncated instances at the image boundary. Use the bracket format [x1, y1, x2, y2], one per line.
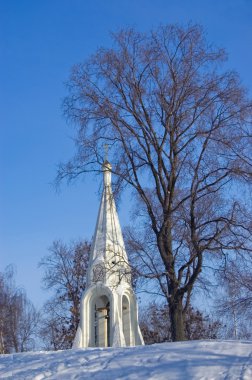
[73, 161, 144, 348]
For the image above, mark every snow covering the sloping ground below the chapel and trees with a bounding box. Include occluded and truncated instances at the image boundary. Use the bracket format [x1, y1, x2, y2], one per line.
[0, 341, 252, 380]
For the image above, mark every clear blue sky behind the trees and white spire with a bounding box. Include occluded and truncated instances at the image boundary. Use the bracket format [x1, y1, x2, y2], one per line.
[0, 0, 252, 306]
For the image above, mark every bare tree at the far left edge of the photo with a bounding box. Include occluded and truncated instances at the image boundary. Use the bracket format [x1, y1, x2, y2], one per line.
[0, 266, 40, 354]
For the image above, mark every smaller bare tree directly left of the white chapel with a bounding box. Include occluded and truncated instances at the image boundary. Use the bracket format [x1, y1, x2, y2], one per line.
[40, 241, 90, 350]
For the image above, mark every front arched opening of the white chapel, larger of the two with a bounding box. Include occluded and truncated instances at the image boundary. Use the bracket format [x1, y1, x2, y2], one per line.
[94, 295, 110, 347]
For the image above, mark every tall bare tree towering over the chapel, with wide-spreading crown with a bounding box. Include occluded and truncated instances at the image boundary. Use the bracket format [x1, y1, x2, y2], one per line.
[58, 25, 252, 340]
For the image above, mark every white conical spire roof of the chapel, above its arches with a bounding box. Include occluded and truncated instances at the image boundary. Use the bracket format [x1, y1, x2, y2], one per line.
[88, 161, 129, 284]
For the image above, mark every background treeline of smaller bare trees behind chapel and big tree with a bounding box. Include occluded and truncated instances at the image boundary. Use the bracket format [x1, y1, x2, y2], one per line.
[0, 241, 252, 354]
